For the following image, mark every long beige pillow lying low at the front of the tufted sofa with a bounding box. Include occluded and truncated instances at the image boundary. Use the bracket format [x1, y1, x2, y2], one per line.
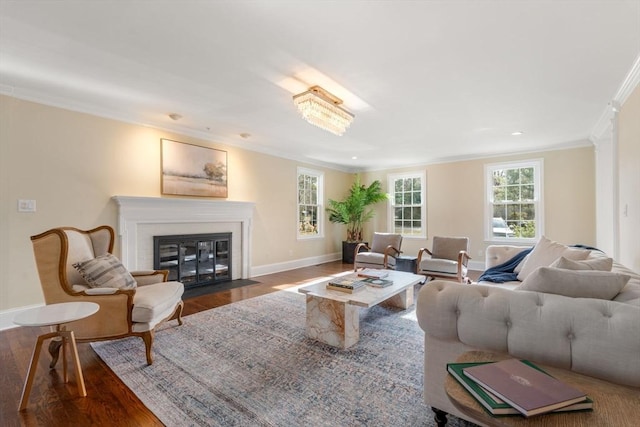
[516, 267, 629, 300]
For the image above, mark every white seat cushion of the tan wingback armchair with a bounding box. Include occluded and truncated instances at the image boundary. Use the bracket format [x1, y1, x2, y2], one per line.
[131, 282, 184, 324]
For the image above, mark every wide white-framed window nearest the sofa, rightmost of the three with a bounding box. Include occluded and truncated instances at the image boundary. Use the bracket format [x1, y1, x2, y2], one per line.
[484, 159, 544, 243]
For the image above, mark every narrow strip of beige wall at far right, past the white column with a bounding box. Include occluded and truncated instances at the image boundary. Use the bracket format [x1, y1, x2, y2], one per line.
[618, 86, 640, 271]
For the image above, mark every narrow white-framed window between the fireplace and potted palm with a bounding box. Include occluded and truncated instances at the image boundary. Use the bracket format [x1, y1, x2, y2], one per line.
[297, 168, 324, 239]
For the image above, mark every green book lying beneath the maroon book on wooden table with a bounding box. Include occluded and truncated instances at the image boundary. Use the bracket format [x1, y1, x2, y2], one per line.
[447, 360, 593, 415]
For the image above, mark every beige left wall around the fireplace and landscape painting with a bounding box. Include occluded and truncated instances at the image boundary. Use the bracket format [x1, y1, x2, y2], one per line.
[0, 96, 352, 310]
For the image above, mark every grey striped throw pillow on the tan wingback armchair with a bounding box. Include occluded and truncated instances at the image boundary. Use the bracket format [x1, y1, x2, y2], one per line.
[73, 254, 136, 289]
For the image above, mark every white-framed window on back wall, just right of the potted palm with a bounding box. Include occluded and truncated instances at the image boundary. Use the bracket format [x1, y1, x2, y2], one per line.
[387, 171, 427, 238]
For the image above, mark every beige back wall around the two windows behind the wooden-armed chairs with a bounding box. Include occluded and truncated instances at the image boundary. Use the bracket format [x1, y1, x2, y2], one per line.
[365, 147, 596, 266]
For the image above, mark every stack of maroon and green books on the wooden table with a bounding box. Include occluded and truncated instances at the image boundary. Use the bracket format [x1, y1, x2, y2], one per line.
[447, 359, 593, 417]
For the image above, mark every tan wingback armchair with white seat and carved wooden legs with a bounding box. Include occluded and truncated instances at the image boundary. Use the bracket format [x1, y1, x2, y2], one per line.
[31, 225, 184, 367]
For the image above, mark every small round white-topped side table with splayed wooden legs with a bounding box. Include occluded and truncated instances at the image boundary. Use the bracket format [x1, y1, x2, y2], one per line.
[13, 302, 100, 411]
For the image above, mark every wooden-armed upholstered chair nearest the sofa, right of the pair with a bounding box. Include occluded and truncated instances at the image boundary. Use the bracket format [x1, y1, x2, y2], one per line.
[416, 236, 471, 283]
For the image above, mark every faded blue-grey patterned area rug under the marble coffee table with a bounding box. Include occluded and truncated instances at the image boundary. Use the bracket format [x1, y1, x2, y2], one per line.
[91, 284, 470, 426]
